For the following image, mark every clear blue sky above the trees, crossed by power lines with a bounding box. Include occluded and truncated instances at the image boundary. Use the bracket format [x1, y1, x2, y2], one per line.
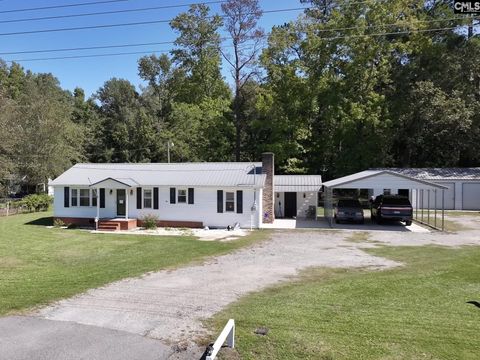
[0, 0, 305, 96]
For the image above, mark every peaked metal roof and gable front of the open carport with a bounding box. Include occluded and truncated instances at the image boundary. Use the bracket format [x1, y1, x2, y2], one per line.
[323, 170, 448, 190]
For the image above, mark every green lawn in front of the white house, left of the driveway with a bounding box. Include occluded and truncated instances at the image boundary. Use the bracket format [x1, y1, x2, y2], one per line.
[0, 213, 268, 315]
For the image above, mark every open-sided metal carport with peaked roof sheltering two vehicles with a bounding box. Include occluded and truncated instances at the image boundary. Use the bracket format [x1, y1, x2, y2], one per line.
[323, 170, 448, 230]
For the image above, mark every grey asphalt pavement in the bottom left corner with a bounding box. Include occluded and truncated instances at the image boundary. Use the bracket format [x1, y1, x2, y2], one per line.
[0, 316, 173, 360]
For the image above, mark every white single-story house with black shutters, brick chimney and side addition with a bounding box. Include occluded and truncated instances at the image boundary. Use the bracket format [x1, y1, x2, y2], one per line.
[49, 153, 322, 230]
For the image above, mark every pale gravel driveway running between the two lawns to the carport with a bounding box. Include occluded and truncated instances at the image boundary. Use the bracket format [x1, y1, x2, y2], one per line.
[10, 218, 480, 358]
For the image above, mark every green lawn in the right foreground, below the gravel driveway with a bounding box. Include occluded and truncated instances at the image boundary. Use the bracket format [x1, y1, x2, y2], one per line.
[210, 247, 480, 359]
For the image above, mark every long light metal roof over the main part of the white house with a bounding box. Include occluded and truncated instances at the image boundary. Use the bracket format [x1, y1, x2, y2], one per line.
[49, 162, 265, 188]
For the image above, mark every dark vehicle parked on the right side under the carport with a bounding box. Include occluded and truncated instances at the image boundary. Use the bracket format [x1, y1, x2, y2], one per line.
[371, 195, 413, 226]
